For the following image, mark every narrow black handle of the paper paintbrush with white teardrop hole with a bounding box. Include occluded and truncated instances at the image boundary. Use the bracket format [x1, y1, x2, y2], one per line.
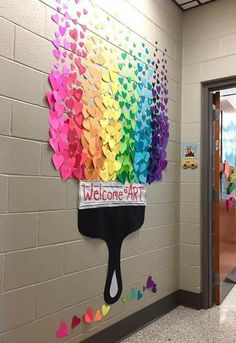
[104, 240, 123, 304]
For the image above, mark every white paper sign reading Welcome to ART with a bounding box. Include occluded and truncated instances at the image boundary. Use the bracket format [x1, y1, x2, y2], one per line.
[79, 181, 146, 209]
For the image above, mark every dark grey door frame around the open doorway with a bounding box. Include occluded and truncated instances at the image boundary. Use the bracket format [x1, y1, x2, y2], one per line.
[201, 76, 236, 308]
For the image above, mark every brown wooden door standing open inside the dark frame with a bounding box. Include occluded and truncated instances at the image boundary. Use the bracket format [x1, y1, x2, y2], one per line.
[213, 92, 236, 305]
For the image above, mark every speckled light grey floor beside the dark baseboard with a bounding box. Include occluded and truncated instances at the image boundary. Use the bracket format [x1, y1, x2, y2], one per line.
[123, 286, 236, 343]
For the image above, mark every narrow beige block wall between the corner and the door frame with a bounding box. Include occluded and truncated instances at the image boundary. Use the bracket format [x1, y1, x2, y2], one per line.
[180, 0, 236, 293]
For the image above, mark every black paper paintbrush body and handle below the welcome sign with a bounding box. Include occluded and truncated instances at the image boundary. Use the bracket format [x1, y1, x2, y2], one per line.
[78, 206, 145, 304]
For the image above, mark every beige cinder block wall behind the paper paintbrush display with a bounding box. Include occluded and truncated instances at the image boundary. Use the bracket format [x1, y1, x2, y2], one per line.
[0, 0, 182, 343]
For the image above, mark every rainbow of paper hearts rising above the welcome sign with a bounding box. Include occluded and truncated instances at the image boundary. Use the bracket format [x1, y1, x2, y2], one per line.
[47, 0, 169, 183]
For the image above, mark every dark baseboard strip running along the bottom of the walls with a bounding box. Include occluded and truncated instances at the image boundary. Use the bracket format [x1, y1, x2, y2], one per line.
[83, 290, 201, 343]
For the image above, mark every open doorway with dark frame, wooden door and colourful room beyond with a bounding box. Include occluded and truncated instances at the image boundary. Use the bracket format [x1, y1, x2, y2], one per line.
[202, 79, 236, 308]
